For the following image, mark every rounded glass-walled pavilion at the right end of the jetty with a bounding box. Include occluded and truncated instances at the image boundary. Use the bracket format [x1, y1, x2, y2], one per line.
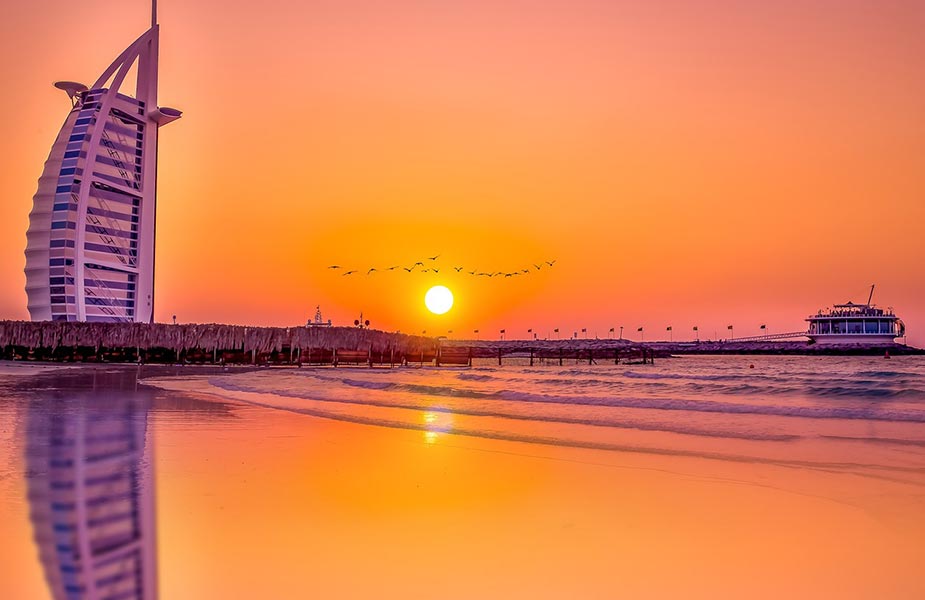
[806, 286, 906, 345]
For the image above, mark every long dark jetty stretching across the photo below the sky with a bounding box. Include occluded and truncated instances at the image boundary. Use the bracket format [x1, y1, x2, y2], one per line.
[0, 321, 912, 367]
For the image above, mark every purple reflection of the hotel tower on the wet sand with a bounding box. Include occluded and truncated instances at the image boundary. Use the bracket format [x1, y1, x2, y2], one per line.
[25, 394, 157, 600]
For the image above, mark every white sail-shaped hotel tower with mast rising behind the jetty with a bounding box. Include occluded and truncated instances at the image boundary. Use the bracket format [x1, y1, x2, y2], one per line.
[25, 3, 180, 323]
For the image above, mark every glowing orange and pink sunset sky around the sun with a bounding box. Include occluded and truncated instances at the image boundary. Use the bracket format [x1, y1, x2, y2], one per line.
[0, 0, 925, 345]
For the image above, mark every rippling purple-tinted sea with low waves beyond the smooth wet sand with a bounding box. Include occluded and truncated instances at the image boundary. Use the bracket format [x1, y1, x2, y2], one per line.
[200, 356, 925, 471]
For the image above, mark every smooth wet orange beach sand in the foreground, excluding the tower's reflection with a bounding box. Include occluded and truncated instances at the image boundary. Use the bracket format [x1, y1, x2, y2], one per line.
[0, 368, 925, 600]
